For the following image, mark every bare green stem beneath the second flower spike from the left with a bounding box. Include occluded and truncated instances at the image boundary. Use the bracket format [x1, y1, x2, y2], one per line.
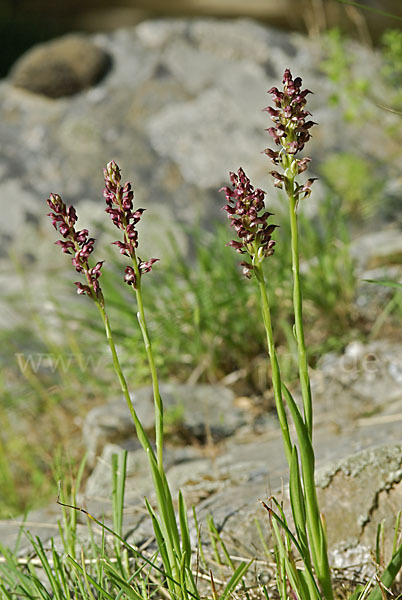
[132, 255, 164, 476]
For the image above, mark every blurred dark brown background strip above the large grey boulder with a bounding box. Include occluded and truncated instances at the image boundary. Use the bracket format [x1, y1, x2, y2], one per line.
[0, 0, 402, 77]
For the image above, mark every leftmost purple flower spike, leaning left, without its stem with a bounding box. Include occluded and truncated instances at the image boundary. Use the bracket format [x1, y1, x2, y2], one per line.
[46, 194, 103, 305]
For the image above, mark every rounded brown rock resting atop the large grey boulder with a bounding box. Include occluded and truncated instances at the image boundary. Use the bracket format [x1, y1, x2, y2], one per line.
[11, 34, 110, 98]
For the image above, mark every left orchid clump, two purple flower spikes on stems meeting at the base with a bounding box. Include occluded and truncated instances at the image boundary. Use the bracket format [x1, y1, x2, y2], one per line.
[47, 166, 198, 598]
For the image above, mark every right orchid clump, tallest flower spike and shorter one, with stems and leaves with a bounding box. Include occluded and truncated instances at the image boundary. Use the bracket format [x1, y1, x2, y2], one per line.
[221, 69, 402, 600]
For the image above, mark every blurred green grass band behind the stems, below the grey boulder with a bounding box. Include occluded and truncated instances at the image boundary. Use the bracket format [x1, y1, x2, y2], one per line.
[0, 185, 398, 517]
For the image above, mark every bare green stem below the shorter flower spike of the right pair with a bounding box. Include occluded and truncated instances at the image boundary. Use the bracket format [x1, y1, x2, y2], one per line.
[254, 261, 292, 466]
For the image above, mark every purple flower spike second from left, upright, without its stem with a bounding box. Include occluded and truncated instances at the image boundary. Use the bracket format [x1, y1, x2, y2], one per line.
[103, 160, 159, 289]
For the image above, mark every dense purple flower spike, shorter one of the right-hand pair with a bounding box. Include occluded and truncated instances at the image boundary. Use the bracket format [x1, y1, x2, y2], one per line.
[219, 168, 277, 278]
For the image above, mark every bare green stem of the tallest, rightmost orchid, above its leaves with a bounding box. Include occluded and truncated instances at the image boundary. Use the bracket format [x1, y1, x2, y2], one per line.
[287, 183, 313, 438]
